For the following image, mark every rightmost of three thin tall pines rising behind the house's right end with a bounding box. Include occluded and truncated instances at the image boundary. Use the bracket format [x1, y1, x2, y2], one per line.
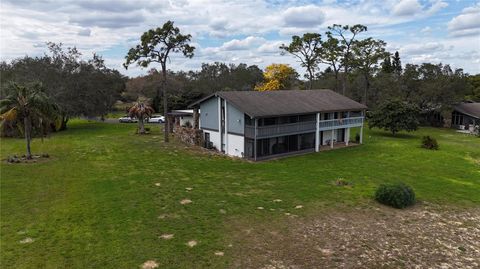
[352, 38, 389, 105]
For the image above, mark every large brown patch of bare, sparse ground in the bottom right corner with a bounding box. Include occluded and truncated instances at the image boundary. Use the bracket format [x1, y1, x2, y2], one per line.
[233, 204, 480, 268]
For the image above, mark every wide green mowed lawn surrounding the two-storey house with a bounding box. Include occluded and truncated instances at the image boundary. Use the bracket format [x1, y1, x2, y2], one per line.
[0, 120, 480, 268]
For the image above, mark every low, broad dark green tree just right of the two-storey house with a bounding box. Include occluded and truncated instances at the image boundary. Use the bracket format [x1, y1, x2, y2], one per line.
[368, 99, 419, 135]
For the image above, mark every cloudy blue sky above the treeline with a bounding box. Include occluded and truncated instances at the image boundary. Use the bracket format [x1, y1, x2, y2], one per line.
[0, 0, 480, 77]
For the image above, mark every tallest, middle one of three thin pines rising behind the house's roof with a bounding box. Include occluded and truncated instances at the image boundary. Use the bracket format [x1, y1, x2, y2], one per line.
[326, 24, 367, 95]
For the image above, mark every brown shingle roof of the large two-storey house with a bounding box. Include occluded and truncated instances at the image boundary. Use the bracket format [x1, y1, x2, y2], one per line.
[190, 90, 367, 118]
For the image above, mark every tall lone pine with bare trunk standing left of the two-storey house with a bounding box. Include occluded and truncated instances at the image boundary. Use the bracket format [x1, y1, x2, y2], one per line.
[123, 21, 195, 142]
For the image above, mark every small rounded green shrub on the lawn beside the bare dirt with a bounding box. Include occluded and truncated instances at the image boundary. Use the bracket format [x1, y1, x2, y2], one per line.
[375, 183, 415, 208]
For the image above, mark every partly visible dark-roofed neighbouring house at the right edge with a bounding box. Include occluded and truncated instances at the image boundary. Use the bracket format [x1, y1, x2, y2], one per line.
[452, 103, 480, 131]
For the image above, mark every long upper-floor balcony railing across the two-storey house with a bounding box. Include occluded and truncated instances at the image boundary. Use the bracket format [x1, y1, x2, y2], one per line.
[245, 117, 363, 139]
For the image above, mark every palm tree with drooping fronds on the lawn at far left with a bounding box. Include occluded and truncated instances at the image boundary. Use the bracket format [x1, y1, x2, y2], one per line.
[0, 83, 56, 159]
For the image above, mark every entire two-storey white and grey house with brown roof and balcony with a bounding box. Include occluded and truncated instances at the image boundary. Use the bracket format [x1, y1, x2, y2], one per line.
[190, 90, 366, 160]
